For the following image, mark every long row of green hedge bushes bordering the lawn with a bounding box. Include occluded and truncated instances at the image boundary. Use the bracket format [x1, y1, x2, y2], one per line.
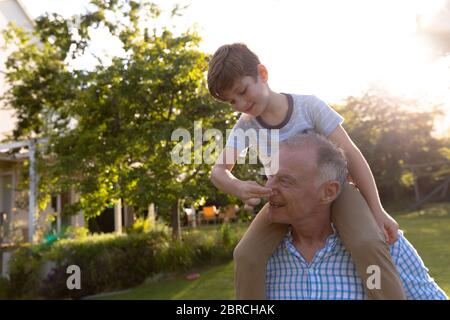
[5, 225, 244, 299]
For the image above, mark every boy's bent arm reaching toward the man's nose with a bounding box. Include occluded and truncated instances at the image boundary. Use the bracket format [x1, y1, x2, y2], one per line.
[211, 147, 271, 206]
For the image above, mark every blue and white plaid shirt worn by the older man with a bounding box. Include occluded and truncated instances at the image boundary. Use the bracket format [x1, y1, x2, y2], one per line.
[266, 232, 448, 300]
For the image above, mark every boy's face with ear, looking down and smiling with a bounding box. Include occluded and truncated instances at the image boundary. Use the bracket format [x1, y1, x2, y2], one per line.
[223, 65, 270, 117]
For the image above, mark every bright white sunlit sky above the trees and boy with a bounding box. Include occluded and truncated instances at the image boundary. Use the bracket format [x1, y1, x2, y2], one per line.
[13, 0, 450, 133]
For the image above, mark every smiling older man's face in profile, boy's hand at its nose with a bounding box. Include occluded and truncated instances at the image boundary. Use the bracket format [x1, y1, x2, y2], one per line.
[266, 147, 320, 224]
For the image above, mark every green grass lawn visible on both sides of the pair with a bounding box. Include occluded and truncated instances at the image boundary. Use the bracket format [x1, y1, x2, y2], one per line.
[89, 205, 450, 300]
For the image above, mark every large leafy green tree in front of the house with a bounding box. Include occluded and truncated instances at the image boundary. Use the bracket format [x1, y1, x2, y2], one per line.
[1, 0, 235, 238]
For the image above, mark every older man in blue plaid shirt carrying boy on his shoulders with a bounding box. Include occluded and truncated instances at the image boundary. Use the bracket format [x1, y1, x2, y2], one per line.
[266, 133, 447, 299]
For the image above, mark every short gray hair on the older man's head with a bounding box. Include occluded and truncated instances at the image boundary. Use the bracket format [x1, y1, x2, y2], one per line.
[280, 132, 348, 190]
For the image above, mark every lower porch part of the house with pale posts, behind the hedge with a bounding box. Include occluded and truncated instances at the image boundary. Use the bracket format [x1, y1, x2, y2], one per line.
[0, 140, 84, 243]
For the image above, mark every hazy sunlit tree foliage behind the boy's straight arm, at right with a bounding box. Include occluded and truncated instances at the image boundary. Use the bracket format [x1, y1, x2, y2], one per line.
[334, 93, 445, 201]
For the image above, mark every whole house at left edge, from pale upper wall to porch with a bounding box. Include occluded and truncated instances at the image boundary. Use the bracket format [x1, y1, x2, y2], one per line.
[0, 0, 84, 243]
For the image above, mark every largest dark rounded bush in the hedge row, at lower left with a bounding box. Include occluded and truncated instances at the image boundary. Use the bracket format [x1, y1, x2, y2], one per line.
[40, 232, 170, 299]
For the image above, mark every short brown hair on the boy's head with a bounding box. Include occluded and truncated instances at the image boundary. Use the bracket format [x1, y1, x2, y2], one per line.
[208, 43, 260, 101]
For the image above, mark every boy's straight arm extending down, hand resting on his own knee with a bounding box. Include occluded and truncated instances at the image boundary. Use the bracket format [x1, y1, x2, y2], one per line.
[328, 125, 398, 243]
